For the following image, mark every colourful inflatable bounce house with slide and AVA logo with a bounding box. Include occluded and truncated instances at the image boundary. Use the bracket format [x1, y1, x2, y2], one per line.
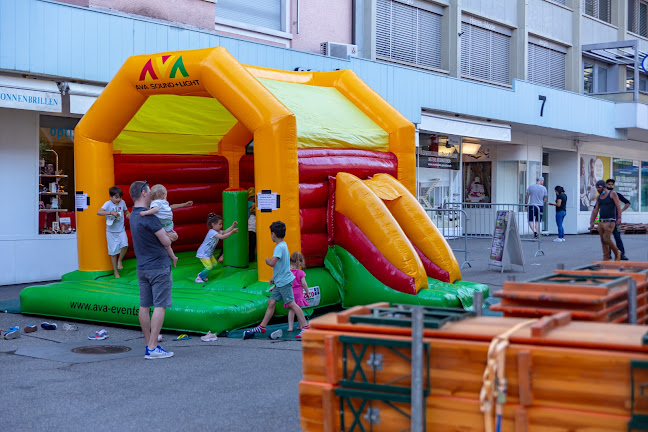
[21, 47, 487, 332]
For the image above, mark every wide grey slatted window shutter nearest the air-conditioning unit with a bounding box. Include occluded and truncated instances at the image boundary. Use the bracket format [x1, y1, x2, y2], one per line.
[376, 0, 441, 68]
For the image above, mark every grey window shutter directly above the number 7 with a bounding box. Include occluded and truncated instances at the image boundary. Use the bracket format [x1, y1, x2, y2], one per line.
[461, 22, 511, 84]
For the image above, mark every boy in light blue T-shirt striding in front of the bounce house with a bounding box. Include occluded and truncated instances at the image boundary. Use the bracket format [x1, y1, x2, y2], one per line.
[243, 221, 309, 339]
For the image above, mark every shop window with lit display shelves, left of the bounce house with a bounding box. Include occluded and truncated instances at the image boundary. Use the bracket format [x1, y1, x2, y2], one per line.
[38, 116, 79, 234]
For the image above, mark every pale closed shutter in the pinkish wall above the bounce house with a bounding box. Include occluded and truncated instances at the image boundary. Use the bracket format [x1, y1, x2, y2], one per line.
[216, 0, 281, 30]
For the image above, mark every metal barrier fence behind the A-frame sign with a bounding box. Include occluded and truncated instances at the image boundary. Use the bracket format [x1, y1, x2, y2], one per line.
[442, 202, 546, 257]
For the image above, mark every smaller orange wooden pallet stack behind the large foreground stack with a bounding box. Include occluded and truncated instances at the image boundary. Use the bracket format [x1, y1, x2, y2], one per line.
[490, 271, 648, 323]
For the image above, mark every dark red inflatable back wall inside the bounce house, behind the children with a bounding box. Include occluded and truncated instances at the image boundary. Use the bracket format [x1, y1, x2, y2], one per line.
[113, 154, 229, 255]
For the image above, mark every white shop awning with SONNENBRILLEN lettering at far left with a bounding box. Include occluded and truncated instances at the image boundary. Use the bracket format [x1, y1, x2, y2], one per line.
[0, 75, 62, 112]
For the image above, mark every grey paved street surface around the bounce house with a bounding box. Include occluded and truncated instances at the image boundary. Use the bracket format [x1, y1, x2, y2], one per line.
[0, 235, 648, 432]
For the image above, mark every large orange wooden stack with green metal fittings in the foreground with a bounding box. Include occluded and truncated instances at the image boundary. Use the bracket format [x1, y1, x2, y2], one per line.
[299, 304, 648, 432]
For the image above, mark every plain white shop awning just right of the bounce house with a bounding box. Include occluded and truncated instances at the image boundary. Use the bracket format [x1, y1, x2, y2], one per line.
[418, 113, 511, 141]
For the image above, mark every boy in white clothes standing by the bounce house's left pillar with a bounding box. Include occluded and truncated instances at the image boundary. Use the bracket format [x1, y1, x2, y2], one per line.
[97, 186, 130, 279]
